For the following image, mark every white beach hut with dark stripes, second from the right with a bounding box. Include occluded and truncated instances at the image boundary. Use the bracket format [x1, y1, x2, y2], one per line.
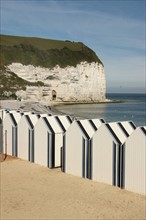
[92, 121, 136, 186]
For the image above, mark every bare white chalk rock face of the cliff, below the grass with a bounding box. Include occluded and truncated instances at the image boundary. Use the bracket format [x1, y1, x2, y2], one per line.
[7, 62, 106, 102]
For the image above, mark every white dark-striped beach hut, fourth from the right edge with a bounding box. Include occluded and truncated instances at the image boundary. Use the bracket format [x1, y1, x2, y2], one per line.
[34, 116, 63, 168]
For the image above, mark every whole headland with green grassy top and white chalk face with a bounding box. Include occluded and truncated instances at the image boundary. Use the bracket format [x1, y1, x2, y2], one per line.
[0, 35, 106, 102]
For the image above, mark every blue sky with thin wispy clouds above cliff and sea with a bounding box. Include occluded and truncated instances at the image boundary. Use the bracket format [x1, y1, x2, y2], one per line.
[1, 0, 146, 93]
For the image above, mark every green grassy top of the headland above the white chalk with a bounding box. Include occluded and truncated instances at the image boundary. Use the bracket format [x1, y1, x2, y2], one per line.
[0, 35, 102, 68]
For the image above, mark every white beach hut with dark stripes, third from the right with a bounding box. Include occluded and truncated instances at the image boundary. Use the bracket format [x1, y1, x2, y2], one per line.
[62, 119, 103, 179]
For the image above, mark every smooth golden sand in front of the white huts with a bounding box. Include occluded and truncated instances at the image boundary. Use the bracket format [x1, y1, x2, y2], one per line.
[0, 157, 146, 220]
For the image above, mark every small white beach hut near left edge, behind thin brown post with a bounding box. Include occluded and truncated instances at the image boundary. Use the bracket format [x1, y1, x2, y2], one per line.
[3, 111, 22, 156]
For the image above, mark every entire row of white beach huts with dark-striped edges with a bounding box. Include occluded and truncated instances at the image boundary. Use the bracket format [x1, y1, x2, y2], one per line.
[0, 109, 146, 195]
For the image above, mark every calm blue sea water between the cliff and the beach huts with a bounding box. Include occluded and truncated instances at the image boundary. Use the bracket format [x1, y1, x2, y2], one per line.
[56, 93, 146, 126]
